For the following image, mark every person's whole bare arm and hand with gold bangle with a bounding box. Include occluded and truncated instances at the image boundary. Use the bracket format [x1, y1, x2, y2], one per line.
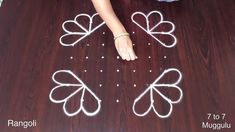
[92, 0, 137, 61]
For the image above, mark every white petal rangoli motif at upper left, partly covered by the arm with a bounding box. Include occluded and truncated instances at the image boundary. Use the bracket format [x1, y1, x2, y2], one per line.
[60, 13, 105, 46]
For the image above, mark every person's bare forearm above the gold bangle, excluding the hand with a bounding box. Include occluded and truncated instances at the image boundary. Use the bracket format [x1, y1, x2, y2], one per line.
[92, 0, 126, 36]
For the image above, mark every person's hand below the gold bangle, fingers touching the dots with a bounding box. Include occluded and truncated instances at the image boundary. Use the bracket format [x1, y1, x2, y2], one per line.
[114, 36, 137, 61]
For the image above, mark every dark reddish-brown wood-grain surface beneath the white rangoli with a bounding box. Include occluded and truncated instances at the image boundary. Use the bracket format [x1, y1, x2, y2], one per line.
[0, 0, 235, 132]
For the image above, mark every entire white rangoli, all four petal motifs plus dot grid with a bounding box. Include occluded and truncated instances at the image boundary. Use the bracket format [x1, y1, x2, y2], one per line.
[49, 11, 183, 118]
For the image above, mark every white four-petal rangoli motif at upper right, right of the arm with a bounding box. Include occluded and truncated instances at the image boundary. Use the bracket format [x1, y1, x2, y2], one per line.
[131, 11, 177, 48]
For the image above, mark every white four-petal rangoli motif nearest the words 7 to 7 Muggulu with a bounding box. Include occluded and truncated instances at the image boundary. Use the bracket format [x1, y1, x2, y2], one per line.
[132, 68, 183, 118]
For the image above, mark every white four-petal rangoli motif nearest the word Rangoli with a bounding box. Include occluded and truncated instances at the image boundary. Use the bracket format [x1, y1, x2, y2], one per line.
[49, 70, 101, 116]
